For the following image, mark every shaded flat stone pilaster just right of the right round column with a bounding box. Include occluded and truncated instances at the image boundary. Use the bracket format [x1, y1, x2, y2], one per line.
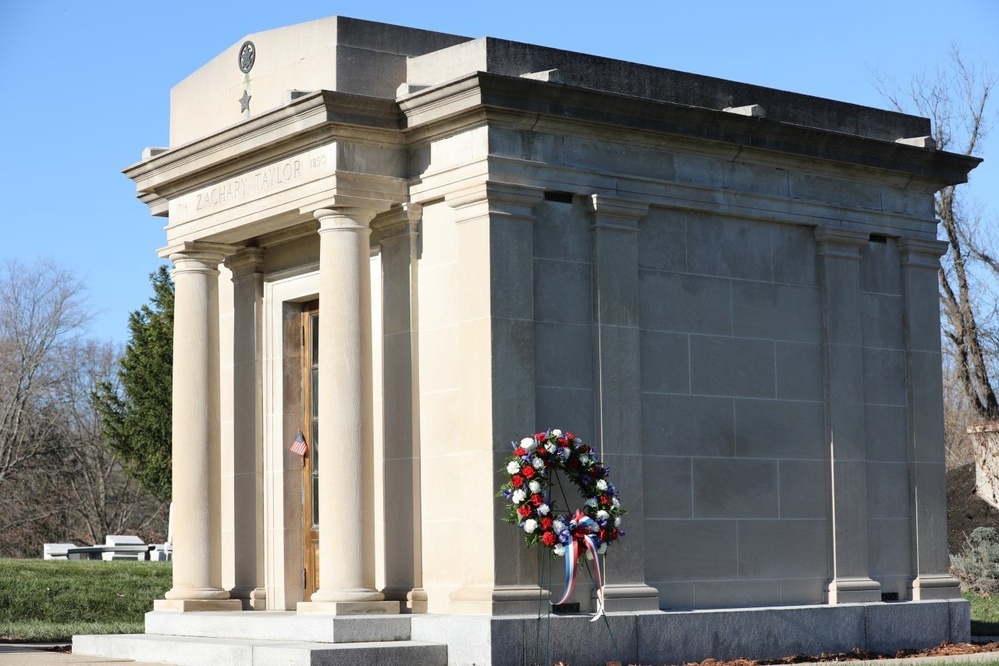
[378, 204, 427, 613]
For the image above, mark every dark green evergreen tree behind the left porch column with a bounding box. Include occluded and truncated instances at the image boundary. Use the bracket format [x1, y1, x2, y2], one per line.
[93, 266, 174, 501]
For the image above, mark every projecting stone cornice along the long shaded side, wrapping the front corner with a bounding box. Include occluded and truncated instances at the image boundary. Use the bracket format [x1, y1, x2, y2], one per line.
[399, 72, 981, 188]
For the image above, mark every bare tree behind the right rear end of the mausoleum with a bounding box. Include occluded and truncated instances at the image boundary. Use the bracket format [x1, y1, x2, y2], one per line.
[878, 47, 999, 421]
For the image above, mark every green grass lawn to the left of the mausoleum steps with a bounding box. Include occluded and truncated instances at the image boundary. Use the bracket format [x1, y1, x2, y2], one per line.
[0, 559, 172, 641]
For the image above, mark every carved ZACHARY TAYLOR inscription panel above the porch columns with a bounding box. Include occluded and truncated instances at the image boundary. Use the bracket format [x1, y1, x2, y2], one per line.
[170, 146, 335, 224]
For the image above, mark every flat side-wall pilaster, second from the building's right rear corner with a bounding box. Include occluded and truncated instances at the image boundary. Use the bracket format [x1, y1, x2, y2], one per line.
[815, 227, 881, 604]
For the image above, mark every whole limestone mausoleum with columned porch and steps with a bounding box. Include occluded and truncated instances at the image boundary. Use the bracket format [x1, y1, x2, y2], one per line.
[75, 17, 977, 666]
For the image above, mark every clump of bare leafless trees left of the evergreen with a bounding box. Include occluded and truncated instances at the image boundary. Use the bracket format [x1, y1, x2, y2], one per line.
[0, 261, 166, 557]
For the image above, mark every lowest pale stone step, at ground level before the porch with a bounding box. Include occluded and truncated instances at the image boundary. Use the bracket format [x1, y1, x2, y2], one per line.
[73, 634, 447, 666]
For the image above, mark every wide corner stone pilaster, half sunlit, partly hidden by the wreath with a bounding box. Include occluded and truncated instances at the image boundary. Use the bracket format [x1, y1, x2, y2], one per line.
[446, 181, 547, 615]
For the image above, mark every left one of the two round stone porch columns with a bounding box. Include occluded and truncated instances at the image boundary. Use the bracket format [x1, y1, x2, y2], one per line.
[154, 243, 242, 611]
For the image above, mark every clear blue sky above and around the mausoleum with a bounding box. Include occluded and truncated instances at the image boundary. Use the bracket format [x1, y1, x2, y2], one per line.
[0, 0, 999, 342]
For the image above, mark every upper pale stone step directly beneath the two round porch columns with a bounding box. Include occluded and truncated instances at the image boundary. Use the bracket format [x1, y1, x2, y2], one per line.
[146, 611, 411, 643]
